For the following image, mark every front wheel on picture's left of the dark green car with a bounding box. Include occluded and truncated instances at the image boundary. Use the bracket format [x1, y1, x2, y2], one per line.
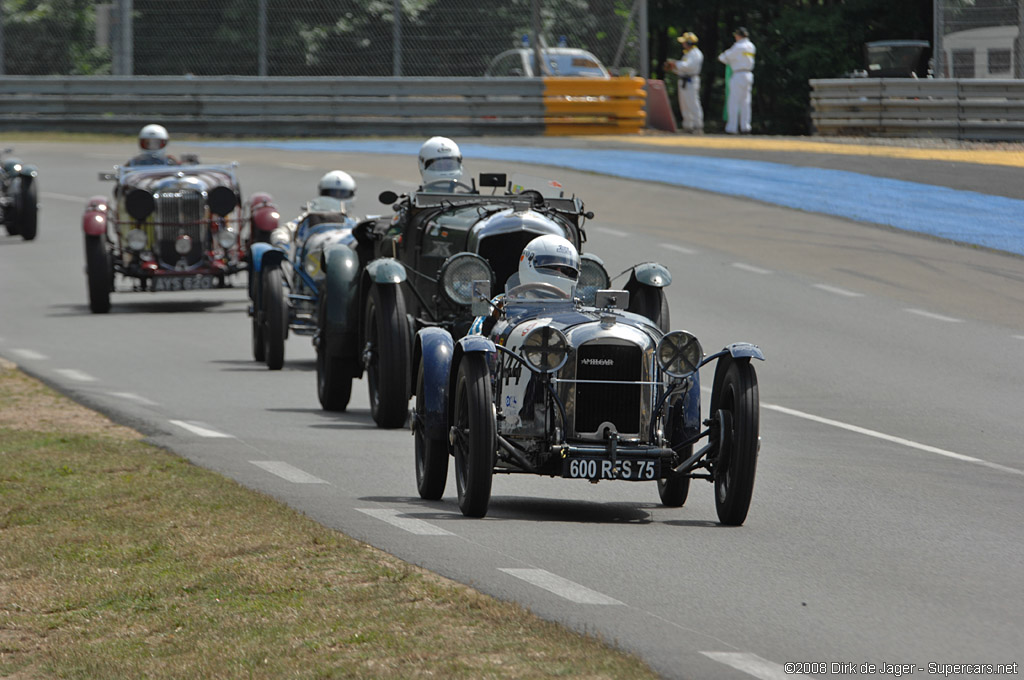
[364, 286, 410, 427]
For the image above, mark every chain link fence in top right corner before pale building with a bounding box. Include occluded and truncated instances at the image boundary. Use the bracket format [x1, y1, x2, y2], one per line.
[933, 0, 1024, 78]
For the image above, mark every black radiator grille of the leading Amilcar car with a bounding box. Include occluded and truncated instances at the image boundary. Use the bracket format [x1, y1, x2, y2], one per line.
[575, 343, 643, 434]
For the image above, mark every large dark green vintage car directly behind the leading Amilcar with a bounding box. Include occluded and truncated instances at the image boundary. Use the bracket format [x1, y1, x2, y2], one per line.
[313, 173, 671, 427]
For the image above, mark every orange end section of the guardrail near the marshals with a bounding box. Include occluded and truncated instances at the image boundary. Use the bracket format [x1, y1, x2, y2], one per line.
[544, 78, 647, 135]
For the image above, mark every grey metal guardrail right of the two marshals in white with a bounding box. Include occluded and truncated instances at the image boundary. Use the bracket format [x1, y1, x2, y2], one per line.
[810, 78, 1024, 141]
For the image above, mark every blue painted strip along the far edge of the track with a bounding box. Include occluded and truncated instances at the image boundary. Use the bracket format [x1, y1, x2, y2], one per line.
[202, 139, 1024, 255]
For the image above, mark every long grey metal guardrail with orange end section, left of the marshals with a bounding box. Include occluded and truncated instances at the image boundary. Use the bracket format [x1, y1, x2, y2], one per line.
[0, 76, 645, 136]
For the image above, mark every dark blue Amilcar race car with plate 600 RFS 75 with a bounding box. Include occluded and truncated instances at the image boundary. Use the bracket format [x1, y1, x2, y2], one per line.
[412, 283, 764, 524]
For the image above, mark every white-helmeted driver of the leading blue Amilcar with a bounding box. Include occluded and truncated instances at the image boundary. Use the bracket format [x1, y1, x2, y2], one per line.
[469, 233, 580, 335]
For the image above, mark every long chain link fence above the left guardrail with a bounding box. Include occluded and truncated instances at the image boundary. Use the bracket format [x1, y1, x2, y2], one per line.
[0, 0, 646, 77]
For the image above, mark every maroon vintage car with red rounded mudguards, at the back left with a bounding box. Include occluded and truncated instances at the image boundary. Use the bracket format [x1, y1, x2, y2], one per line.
[82, 164, 278, 313]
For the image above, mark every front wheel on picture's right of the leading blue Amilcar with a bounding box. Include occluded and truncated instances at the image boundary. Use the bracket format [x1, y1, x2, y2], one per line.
[715, 362, 760, 526]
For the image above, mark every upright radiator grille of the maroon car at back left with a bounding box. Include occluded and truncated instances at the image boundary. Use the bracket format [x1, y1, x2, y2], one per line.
[154, 188, 210, 269]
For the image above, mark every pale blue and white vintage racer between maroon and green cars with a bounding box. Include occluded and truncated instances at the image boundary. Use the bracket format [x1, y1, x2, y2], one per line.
[249, 196, 355, 371]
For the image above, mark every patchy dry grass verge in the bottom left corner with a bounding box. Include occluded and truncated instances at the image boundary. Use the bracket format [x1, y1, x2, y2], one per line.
[0, 359, 657, 680]
